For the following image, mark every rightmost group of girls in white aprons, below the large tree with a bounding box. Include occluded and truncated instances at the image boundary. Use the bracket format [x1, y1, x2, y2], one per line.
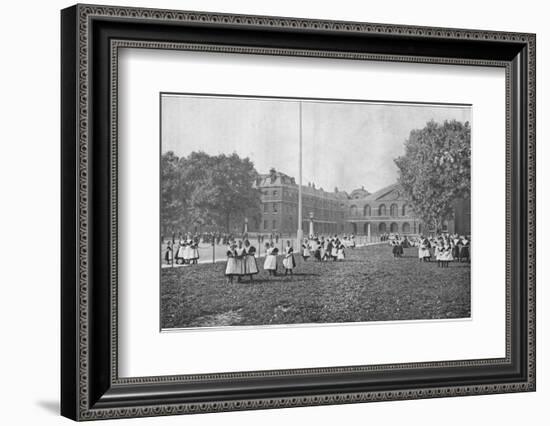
[418, 234, 470, 268]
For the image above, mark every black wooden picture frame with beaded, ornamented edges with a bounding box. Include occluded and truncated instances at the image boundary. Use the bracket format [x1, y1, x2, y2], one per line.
[61, 5, 535, 420]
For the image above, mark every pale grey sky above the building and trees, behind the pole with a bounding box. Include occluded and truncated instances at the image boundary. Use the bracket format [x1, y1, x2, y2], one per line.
[161, 94, 471, 192]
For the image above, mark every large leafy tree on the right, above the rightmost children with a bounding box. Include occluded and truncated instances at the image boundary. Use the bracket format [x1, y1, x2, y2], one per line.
[395, 120, 471, 230]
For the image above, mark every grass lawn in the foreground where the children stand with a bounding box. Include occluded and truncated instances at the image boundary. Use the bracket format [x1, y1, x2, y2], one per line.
[161, 244, 470, 328]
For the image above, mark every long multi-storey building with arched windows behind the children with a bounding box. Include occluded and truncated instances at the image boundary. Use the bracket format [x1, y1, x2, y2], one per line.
[247, 169, 470, 237]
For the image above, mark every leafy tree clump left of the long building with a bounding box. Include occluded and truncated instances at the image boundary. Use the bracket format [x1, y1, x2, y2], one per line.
[161, 152, 261, 232]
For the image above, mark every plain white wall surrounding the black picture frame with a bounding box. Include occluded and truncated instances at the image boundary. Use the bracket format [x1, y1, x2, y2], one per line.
[0, 0, 550, 426]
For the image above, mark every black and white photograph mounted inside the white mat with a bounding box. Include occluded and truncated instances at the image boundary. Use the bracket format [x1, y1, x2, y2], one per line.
[159, 93, 474, 330]
